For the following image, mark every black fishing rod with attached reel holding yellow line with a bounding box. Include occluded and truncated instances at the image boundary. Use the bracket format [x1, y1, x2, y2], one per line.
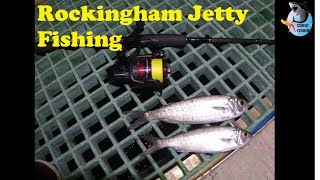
[35, 21, 275, 92]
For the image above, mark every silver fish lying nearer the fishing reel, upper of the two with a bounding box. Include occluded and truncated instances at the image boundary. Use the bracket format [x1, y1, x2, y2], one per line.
[125, 95, 249, 130]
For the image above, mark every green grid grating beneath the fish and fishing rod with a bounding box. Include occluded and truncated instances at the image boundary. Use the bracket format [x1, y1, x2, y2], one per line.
[35, 0, 275, 179]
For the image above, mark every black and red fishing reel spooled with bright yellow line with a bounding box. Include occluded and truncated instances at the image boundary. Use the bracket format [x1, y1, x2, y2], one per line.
[107, 21, 170, 92]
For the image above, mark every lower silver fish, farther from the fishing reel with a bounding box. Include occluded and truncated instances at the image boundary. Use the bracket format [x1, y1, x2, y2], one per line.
[141, 126, 252, 156]
